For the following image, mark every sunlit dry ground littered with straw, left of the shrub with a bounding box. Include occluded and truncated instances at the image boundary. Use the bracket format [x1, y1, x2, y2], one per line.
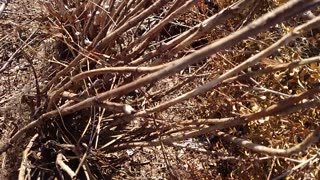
[0, 0, 49, 179]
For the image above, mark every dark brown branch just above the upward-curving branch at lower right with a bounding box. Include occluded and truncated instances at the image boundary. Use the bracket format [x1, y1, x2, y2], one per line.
[103, 87, 320, 152]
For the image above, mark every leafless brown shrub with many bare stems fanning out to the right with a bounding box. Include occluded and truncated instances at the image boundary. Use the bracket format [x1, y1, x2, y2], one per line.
[0, 0, 320, 178]
